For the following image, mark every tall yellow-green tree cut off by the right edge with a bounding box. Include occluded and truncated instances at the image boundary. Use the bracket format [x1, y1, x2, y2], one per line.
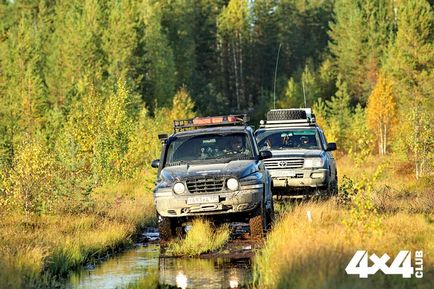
[386, 0, 434, 178]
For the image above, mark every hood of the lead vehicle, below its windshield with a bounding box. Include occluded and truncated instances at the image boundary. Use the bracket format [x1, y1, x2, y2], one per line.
[161, 160, 258, 181]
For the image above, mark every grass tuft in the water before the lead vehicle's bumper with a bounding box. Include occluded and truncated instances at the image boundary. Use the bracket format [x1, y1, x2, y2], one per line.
[167, 219, 230, 257]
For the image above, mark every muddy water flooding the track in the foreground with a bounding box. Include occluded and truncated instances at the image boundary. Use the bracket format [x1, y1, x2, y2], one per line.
[67, 244, 252, 289]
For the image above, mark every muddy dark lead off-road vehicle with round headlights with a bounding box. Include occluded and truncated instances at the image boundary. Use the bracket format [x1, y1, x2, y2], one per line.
[152, 115, 274, 241]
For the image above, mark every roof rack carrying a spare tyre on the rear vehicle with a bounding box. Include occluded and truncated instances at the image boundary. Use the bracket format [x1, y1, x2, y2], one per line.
[261, 108, 316, 128]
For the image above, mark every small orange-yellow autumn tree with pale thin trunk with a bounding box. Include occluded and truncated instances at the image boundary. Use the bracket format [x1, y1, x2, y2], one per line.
[367, 74, 397, 155]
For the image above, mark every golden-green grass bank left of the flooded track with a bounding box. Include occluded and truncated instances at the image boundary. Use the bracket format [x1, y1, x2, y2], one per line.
[0, 172, 155, 289]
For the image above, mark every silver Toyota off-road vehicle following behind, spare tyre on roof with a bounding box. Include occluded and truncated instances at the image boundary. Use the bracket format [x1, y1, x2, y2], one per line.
[255, 108, 337, 196]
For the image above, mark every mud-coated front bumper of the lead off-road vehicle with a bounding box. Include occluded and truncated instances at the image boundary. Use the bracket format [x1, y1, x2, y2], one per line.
[154, 184, 263, 217]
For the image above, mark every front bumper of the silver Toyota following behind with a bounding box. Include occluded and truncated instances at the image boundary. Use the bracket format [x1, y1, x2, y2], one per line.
[269, 169, 329, 188]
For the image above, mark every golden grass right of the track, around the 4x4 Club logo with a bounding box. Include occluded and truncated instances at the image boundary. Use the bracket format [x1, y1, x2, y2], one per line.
[253, 158, 434, 288]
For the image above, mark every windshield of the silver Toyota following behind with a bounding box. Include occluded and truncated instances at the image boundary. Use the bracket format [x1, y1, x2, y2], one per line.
[256, 129, 321, 150]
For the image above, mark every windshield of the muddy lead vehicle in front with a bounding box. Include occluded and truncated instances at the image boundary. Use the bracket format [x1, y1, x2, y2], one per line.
[166, 133, 254, 166]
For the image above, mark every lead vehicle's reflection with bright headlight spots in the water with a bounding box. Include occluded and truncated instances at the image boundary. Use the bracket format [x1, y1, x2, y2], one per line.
[160, 258, 251, 289]
